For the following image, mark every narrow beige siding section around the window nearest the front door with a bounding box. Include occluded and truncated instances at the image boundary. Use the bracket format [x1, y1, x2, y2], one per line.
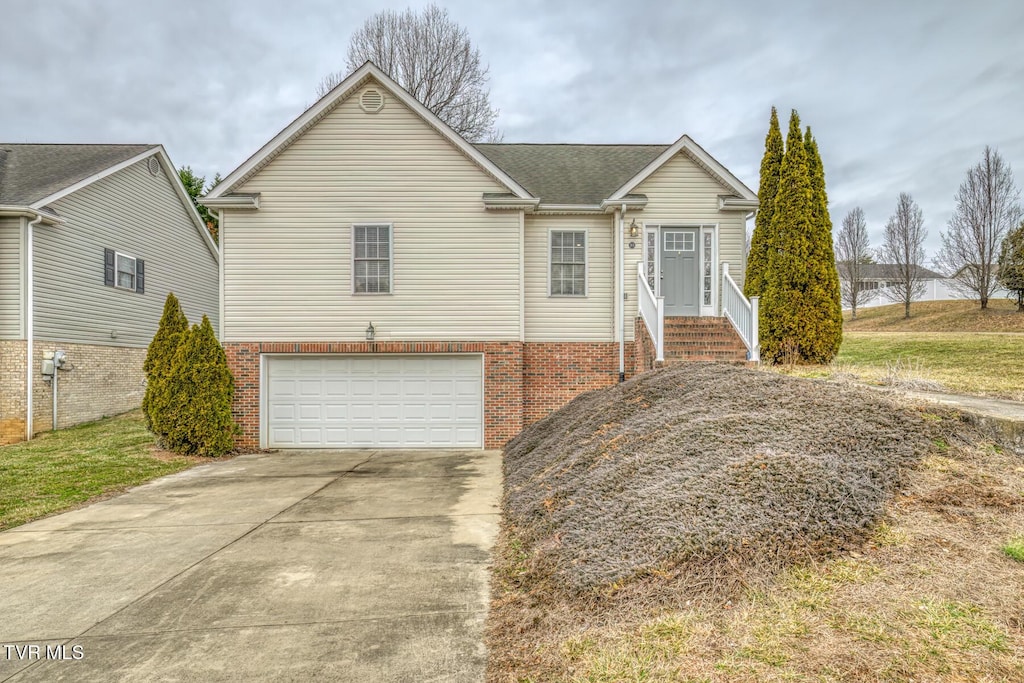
[525, 215, 614, 341]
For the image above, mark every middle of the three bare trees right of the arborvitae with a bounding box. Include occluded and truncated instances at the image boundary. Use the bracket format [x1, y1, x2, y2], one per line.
[881, 193, 928, 317]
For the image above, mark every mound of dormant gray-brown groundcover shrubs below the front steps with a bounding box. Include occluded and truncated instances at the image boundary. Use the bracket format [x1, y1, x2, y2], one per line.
[504, 364, 950, 593]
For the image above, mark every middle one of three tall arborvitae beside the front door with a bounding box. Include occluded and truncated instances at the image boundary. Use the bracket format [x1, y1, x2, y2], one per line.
[760, 110, 813, 362]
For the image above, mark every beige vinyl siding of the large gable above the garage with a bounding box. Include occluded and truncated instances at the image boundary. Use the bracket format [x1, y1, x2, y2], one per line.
[229, 80, 520, 341]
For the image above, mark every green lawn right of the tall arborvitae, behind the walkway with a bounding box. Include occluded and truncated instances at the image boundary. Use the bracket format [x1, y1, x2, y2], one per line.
[787, 331, 1024, 400]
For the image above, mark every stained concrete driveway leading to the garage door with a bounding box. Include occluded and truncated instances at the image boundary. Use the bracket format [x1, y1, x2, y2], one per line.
[0, 451, 501, 682]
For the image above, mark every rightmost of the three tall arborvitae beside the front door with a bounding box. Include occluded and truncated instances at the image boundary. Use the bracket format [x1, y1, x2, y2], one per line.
[801, 126, 843, 364]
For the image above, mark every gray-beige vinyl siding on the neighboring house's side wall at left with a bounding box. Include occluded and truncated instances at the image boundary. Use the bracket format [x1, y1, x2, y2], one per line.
[34, 160, 217, 346]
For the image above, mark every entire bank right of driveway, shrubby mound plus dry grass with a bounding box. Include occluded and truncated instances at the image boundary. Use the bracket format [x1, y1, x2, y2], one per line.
[487, 366, 1024, 683]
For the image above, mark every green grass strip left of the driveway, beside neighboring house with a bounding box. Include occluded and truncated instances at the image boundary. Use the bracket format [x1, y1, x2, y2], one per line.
[0, 411, 201, 529]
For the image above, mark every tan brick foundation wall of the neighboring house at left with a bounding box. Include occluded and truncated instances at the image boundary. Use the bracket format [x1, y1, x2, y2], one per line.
[0, 339, 146, 443]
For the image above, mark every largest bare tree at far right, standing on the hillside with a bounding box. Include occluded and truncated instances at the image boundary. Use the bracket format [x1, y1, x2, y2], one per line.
[935, 146, 1022, 308]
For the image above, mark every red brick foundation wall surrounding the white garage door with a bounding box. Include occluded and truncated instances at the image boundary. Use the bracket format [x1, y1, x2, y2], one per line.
[223, 342, 647, 449]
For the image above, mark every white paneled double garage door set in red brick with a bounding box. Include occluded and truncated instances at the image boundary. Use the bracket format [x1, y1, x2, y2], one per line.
[264, 354, 483, 449]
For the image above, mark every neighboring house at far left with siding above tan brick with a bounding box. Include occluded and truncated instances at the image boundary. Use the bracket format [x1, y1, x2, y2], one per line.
[0, 143, 219, 443]
